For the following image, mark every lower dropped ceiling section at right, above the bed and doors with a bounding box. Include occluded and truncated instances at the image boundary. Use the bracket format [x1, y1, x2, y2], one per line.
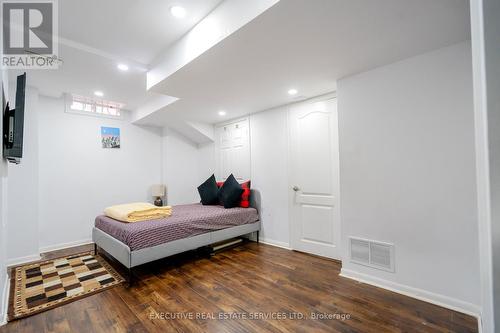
[139, 0, 470, 125]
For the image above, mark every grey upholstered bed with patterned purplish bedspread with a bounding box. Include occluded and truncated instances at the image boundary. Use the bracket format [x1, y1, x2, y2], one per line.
[92, 190, 260, 277]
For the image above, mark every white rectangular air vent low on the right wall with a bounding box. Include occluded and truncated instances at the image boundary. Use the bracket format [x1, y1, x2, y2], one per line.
[349, 237, 394, 272]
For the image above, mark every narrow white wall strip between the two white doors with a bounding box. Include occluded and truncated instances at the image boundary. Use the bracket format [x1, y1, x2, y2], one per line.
[250, 106, 290, 247]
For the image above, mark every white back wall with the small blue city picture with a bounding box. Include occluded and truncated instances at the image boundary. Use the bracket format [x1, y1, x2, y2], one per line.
[39, 96, 162, 251]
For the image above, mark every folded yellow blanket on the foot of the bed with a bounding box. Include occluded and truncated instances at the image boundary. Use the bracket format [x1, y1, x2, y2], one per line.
[104, 202, 172, 222]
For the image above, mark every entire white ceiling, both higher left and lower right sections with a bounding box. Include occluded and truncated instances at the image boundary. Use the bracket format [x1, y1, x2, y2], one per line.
[10, 0, 470, 136]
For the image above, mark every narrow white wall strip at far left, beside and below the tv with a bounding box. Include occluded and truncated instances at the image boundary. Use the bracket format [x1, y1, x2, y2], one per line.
[7, 86, 39, 264]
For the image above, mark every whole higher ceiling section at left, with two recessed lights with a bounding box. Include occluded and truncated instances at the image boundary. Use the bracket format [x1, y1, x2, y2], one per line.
[9, 0, 222, 110]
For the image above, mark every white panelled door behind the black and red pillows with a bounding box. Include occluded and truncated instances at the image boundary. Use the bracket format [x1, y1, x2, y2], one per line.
[216, 119, 250, 182]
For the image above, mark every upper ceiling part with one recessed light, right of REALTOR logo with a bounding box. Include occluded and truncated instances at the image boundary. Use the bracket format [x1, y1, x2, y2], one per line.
[58, 0, 222, 64]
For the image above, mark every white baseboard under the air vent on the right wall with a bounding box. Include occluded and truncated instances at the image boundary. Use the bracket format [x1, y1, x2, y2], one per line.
[340, 268, 481, 320]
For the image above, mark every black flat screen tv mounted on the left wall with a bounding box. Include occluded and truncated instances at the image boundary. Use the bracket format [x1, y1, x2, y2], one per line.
[3, 73, 26, 164]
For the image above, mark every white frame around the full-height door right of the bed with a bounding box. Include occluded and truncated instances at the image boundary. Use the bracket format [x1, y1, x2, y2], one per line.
[287, 91, 343, 261]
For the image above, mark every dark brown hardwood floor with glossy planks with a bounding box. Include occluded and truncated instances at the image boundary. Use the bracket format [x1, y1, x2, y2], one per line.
[0, 243, 477, 333]
